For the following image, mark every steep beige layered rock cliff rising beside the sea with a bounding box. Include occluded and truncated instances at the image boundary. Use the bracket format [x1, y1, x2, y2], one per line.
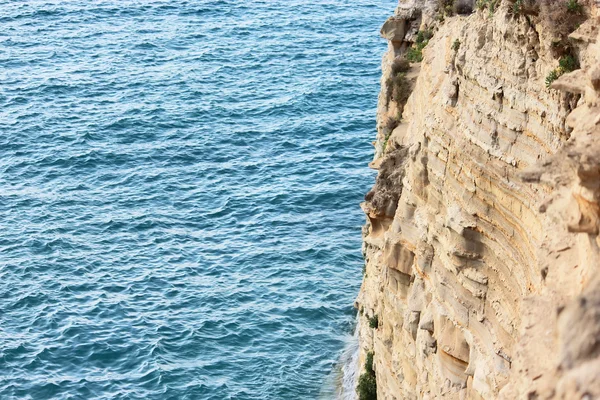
[356, 0, 600, 399]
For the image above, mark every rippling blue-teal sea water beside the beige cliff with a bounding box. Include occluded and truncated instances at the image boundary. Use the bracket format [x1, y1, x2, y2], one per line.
[0, 0, 396, 400]
